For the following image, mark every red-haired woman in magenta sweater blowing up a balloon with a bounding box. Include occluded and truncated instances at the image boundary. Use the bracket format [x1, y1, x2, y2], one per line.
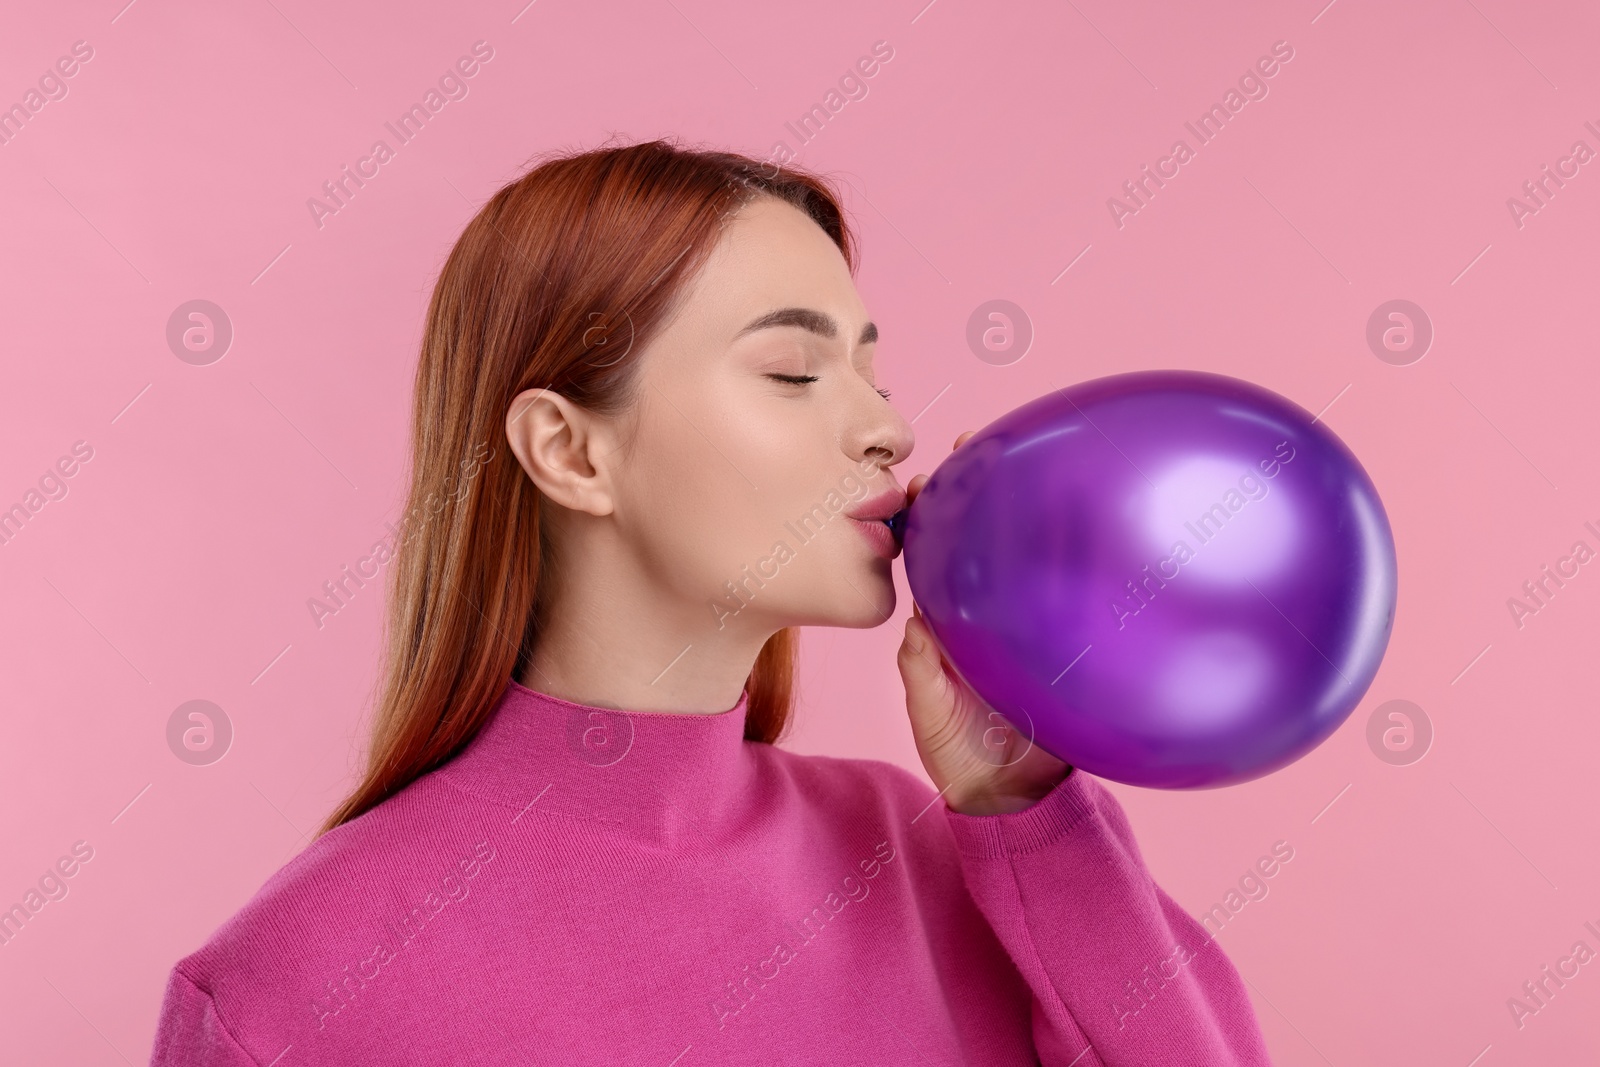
[152, 142, 1269, 1067]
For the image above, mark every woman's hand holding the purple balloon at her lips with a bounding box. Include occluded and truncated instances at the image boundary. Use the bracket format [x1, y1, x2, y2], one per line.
[898, 430, 1072, 816]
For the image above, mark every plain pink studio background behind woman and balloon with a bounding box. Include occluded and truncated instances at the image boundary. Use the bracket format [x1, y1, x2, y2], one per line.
[0, 0, 1600, 1067]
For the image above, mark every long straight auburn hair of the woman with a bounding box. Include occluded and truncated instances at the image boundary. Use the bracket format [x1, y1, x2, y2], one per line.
[318, 141, 856, 833]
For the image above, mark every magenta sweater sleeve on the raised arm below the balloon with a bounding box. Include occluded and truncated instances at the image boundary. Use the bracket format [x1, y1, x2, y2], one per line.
[944, 768, 1272, 1067]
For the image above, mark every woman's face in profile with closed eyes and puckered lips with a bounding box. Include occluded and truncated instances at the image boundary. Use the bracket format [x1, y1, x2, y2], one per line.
[614, 197, 914, 640]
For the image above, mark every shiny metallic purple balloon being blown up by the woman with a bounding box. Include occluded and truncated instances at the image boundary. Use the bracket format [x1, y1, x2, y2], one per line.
[896, 370, 1397, 789]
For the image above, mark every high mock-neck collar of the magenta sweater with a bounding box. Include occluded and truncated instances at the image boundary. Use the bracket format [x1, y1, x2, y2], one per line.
[442, 680, 755, 846]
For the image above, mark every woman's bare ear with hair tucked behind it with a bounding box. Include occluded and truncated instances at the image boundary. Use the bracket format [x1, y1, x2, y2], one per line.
[506, 389, 616, 515]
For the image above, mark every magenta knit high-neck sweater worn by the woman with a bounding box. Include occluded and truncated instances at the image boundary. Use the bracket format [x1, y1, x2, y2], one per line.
[150, 683, 1270, 1067]
